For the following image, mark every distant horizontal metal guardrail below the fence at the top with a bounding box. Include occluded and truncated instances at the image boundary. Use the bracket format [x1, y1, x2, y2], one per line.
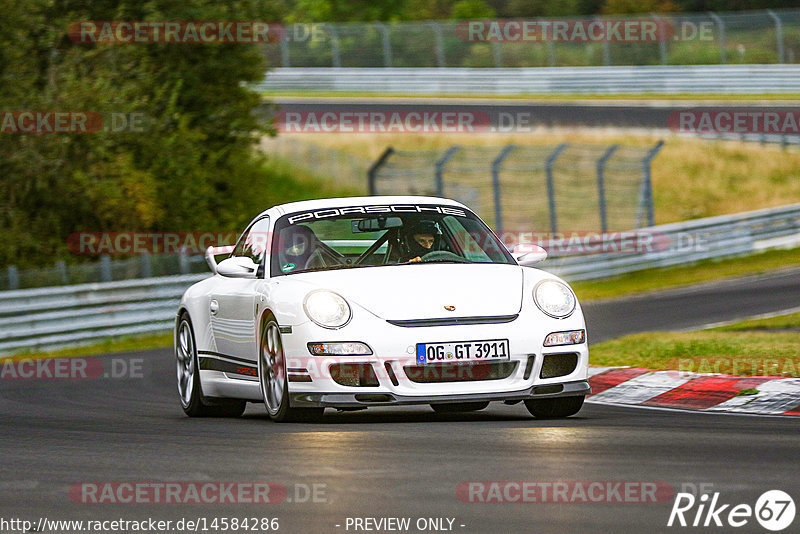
[255, 65, 800, 95]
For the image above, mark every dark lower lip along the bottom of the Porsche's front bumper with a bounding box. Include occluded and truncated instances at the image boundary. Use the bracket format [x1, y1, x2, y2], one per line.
[289, 380, 591, 408]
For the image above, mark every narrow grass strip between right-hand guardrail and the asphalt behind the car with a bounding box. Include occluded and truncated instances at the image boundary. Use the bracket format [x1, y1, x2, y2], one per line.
[572, 248, 800, 302]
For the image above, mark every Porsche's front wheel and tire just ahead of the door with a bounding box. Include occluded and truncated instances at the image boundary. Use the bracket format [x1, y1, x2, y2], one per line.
[258, 315, 325, 423]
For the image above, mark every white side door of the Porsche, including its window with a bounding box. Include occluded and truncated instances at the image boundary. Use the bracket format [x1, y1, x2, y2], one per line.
[209, 217, 269, 363]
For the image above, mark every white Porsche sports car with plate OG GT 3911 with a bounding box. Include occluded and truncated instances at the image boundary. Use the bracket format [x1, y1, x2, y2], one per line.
[175, 196, 590, 421]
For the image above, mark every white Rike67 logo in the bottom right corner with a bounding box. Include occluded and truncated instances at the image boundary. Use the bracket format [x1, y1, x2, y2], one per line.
[667, 490, 795, 532]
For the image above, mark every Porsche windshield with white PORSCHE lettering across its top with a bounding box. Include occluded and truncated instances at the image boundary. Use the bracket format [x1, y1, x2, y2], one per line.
[271, 204, 514, 276]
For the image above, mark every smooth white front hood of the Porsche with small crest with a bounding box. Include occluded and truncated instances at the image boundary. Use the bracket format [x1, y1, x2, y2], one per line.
[294, 263, 523, 320]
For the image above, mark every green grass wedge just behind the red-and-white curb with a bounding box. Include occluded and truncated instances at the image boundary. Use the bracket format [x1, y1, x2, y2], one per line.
[589, 313, 800, 377]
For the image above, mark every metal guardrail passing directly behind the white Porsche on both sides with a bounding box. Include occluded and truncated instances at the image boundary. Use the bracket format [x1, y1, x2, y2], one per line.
[0, 204, 800, 354]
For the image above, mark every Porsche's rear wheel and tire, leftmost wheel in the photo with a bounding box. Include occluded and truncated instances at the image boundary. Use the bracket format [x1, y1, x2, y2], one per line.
[175, 313, 247, 417]
